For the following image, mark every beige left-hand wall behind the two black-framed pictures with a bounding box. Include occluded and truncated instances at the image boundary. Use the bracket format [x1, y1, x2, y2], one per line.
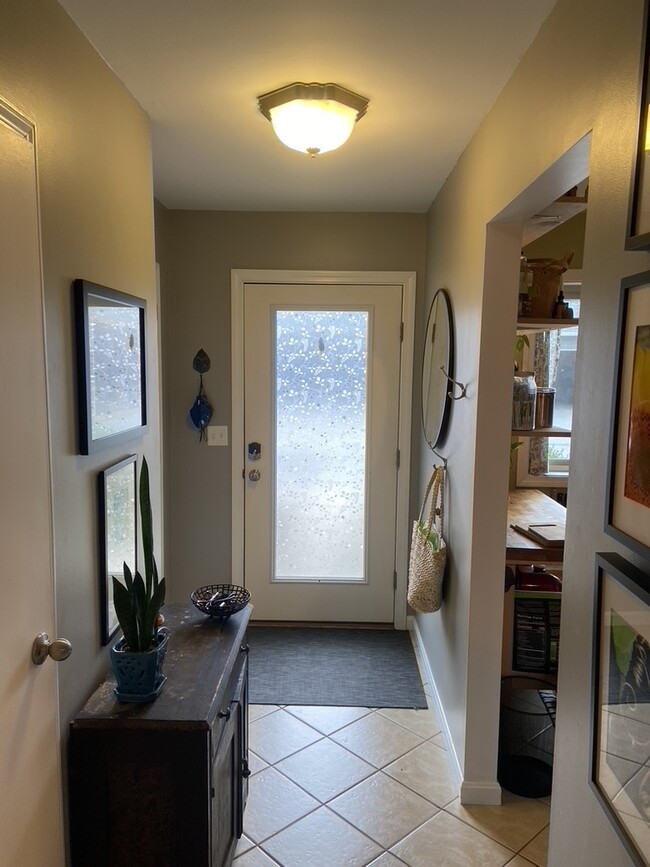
[0, 0, 160, 733]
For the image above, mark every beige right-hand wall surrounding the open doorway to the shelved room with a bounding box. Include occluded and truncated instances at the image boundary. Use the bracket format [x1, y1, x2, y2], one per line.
[419, 0, 650, 867]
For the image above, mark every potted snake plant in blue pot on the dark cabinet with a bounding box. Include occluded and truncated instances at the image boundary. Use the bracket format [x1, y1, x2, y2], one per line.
[111, 458, 169, 702]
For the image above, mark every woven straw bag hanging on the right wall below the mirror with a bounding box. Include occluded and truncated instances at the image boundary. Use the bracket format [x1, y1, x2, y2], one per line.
[406, 467, 447, 614]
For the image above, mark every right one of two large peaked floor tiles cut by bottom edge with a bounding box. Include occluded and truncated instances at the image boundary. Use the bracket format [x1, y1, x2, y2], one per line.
[391, 810, 514, 867]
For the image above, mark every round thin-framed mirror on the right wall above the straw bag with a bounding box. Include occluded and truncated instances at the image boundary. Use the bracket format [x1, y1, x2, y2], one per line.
[422, 289, 454, 448]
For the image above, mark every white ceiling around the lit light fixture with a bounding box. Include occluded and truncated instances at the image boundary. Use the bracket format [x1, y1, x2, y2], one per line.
[59, 0, 556, 212]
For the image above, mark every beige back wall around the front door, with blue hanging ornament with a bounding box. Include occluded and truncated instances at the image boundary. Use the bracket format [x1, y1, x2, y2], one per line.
[156, 205, 426, 599]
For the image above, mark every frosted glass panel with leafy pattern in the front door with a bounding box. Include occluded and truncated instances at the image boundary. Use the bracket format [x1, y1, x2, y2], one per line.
[274, 310, 369, 581]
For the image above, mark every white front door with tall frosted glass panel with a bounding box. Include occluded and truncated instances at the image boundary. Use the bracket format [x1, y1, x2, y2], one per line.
[244, 283, 402, 622]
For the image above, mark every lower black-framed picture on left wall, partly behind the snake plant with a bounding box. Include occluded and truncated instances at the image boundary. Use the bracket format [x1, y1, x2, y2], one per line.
[98, 455, 137, 644]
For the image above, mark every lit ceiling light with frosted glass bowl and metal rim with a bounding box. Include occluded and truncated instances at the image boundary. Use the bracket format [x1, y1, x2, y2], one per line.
[257, 81, 368, 157]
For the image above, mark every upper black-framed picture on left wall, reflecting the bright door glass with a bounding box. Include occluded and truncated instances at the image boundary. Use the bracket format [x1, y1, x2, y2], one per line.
[74, 280, 147, 455]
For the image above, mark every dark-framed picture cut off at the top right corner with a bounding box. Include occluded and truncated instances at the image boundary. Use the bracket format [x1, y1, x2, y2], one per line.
[625, 0, 650, 250]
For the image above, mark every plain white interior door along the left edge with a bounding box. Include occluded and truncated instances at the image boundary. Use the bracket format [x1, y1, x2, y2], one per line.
[0, 101, 63, 867]
